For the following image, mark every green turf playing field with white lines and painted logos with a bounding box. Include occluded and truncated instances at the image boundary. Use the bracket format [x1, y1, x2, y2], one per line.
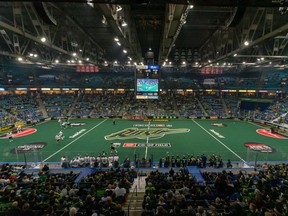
[0, 119, 288, 162]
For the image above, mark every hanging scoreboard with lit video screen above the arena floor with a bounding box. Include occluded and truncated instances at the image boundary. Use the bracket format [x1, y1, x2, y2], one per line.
[135, 65, 160, 99]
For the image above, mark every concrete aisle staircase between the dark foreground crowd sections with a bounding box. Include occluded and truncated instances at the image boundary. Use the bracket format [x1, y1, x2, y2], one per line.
[123, 176, 146, 216]
